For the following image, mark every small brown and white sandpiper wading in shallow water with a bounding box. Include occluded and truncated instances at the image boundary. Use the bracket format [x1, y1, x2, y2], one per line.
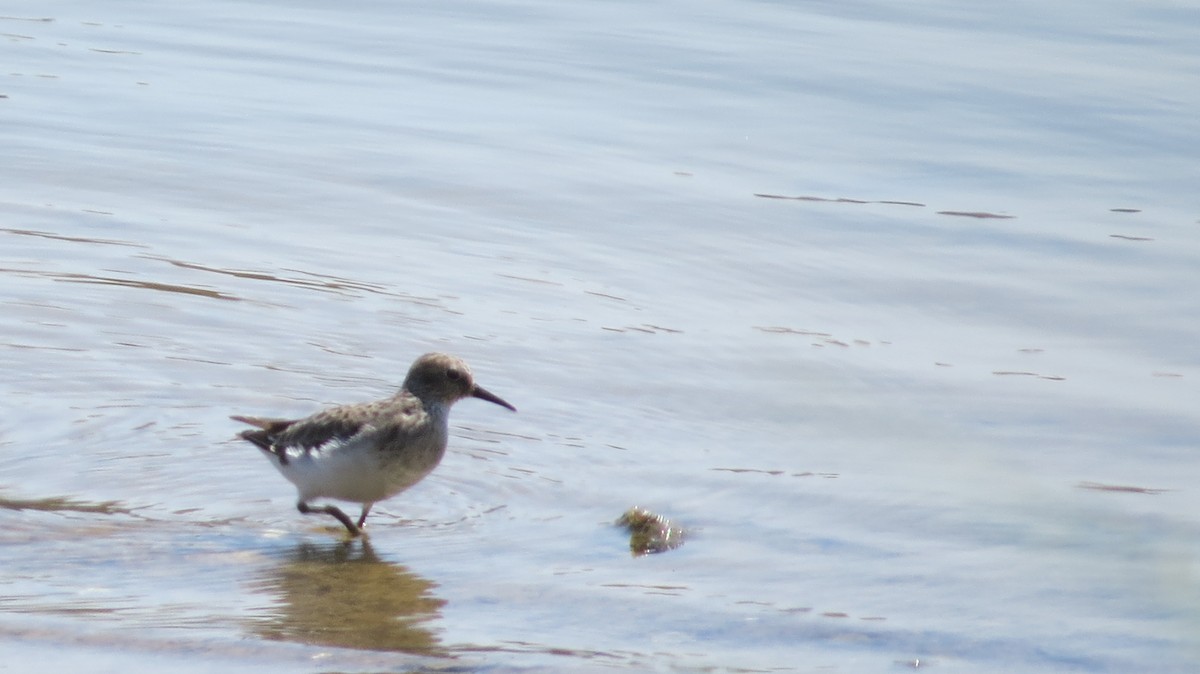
[232, 354, 517, 536]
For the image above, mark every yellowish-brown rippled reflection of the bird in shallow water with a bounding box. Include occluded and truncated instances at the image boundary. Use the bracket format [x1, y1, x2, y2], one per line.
[252, 538, 446, 655]
